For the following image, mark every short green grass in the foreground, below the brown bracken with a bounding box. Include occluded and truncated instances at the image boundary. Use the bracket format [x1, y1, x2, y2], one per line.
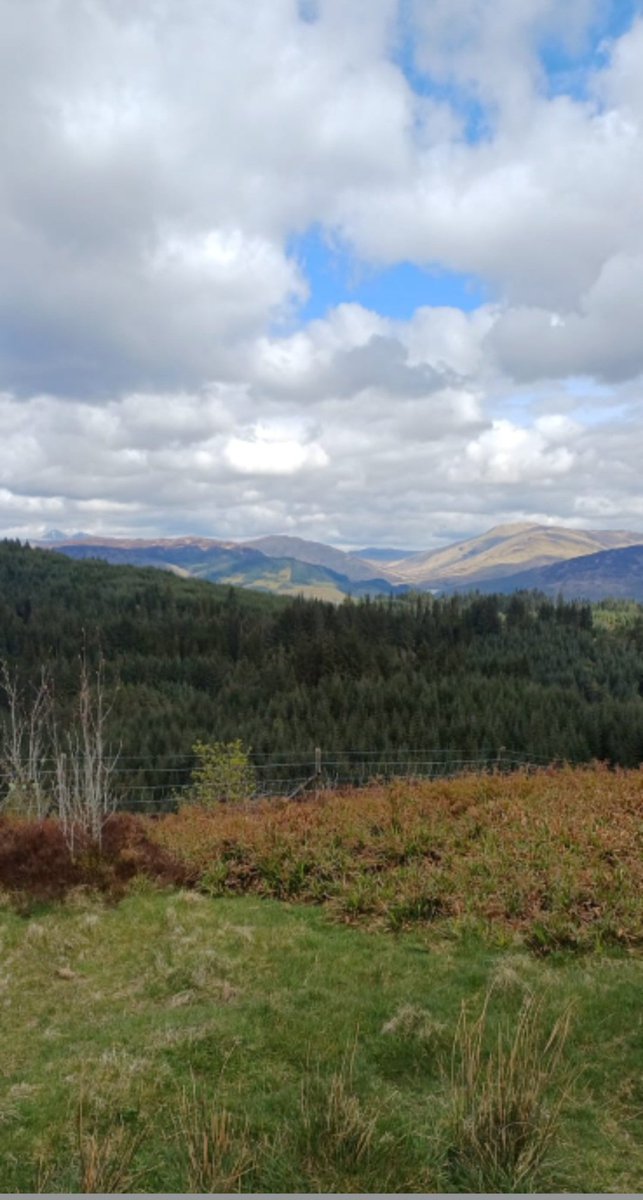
[0, 887, 643, 1193]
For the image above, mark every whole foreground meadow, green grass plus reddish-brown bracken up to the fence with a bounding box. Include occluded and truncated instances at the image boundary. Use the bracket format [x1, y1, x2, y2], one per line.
[0, 770, 643, 1193]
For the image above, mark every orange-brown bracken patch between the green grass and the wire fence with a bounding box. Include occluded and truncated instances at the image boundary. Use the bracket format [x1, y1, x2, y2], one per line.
[151, 768, 643, 954]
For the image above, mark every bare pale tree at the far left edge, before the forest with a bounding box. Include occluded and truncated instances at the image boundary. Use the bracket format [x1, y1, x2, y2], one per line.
[0, 660, 53, 820]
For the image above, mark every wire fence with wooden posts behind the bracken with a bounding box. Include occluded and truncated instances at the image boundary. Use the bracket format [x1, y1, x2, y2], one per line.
[94, 746, 551, 815]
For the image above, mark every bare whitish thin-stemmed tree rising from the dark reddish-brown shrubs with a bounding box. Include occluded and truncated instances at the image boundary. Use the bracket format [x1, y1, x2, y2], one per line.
[54, 655, 119, 852]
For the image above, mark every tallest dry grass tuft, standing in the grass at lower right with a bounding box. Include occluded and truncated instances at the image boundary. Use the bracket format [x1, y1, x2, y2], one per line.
[446, 991, 573, 1192]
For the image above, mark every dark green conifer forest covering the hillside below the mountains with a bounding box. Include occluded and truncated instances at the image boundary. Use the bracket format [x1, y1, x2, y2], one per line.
[0, 542, 643, 786]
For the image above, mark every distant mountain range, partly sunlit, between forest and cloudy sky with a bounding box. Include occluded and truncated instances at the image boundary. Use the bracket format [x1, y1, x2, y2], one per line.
[31, 524, 643, 601]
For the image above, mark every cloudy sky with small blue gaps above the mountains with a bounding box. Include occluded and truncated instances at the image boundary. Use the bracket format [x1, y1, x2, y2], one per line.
[0, 0, 643, 550]
